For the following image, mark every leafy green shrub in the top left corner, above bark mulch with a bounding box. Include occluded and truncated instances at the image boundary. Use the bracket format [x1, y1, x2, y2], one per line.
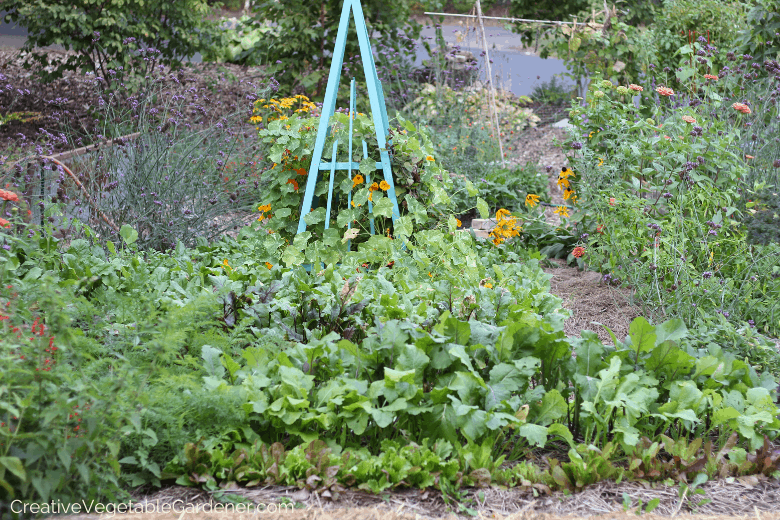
[2, 0, 217, 80]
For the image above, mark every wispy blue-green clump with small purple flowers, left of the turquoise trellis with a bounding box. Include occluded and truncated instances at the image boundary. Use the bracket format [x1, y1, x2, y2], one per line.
[4, 61, 267, 250]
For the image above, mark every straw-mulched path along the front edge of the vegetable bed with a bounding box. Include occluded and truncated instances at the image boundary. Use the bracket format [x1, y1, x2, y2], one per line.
[60, 476, 780, 520]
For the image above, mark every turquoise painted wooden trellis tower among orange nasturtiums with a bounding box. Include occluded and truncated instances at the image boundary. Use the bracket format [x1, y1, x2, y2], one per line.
[297, 0, 400, 242]
